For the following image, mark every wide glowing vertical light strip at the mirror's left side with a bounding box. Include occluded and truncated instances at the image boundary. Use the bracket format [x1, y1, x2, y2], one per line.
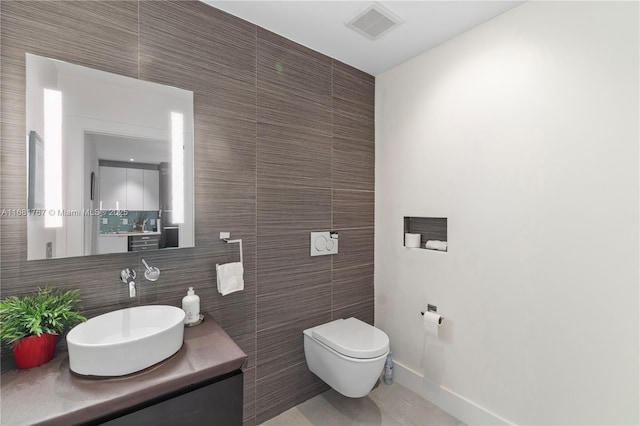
[44, 89, 62, 228]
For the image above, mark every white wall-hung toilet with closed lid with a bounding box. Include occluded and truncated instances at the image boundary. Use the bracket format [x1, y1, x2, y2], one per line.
[303, 318, 389, 398]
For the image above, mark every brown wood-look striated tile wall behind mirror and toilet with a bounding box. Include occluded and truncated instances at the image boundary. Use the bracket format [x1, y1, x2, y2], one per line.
[0, 0, 375, 425]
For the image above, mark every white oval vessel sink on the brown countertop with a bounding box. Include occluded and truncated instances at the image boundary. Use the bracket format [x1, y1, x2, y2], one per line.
[67, 305, 185, 377]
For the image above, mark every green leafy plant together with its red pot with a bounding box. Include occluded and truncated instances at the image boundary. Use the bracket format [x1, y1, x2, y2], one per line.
[0, 288, 87, 368]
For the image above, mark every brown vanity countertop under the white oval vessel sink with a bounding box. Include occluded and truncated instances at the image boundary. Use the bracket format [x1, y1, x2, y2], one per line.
[0, 314, 247, 426]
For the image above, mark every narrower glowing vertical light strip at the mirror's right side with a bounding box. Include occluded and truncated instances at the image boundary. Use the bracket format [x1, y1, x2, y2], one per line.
[171, 112, 184, 223]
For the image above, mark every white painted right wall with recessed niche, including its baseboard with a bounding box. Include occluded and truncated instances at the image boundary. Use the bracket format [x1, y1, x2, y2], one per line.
[375, 2, 640, 425]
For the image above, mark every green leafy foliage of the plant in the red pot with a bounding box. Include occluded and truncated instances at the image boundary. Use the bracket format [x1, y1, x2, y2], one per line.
[0, 288, 87, 345]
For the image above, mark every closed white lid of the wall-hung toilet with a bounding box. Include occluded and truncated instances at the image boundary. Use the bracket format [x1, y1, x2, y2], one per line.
[311, 318, 389, 359]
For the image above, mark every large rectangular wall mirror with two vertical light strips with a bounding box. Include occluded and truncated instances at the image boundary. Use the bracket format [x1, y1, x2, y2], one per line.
[26, 54, 195, 260]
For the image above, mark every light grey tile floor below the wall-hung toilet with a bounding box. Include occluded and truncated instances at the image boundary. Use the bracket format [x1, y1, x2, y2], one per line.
[261, 383, 464, 426]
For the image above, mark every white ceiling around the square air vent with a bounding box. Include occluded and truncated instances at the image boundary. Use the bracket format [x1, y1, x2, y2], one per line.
[201, 0, 524, 75]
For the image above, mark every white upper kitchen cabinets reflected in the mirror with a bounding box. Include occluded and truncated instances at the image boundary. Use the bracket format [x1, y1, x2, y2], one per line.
[100, 166, 160, 210]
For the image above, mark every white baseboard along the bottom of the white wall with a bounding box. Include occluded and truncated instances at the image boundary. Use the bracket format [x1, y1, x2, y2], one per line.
[393, 360, 514, 425]
